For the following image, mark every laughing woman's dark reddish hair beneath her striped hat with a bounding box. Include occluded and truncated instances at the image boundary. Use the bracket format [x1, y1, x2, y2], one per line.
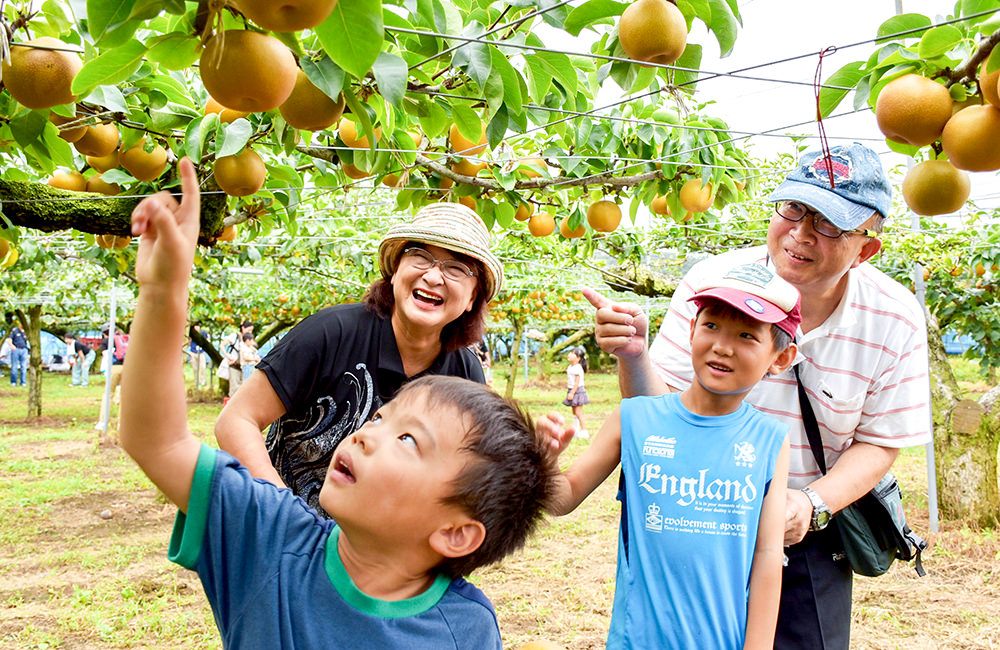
[362, 242, 490, 352]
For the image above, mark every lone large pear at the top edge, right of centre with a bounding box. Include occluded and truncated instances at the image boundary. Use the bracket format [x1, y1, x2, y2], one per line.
[618, 0, 687, 65]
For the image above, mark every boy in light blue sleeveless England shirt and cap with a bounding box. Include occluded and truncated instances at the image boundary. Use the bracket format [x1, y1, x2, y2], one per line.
[551, 264, 801, 650]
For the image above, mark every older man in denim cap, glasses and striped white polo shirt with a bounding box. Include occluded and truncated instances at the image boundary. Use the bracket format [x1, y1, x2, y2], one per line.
[587, 143, 931, 650]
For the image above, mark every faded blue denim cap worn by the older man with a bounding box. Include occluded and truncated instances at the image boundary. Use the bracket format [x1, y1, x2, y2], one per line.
[769, 142, 892, 230]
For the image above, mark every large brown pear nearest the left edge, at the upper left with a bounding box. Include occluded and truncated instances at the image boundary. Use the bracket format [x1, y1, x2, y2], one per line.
[3, 36, 83, 108]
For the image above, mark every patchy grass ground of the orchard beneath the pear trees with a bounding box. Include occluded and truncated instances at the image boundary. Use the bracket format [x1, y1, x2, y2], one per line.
[0, 362, 1000, 650]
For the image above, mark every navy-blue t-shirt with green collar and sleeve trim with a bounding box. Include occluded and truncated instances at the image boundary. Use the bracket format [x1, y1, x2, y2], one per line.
[169, 446, 503, 650]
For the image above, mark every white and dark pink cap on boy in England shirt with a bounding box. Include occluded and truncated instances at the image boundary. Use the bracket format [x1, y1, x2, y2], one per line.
[688, 263, 802, 339]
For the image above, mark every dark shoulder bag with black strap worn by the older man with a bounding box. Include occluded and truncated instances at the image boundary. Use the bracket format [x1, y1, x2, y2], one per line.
[795, 366, 927, 577]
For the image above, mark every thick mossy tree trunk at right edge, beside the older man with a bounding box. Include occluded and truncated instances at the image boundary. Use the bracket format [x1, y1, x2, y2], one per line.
[927, 318, 1000, 527]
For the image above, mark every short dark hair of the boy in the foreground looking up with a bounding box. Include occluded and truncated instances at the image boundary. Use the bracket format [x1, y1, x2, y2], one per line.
[396, 375, 555, 578]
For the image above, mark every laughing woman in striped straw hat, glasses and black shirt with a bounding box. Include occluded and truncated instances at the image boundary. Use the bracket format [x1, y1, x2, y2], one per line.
[215, 203, 503, 512]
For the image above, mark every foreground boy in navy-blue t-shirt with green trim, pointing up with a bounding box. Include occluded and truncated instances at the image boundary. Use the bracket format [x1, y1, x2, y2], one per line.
[120, 159, 553, 650]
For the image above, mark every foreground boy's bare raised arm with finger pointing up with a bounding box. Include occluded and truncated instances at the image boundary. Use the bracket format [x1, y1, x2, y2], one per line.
[120, 158, 201, 512]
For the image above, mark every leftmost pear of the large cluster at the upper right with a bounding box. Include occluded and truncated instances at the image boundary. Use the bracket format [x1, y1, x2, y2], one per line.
[875, 74, 952, 147]
